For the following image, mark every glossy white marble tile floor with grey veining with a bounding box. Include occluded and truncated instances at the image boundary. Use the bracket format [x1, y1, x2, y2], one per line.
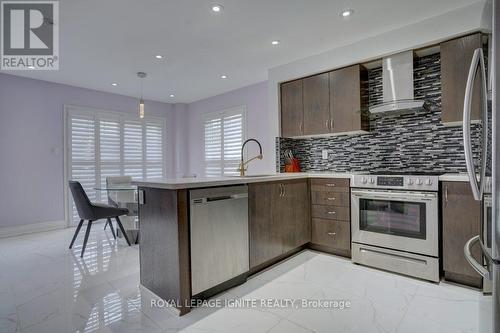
[0, 224, 487, 333]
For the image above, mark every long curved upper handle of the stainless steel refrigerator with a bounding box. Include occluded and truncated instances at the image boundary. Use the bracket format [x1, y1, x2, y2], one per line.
[463, 48, 488, 201]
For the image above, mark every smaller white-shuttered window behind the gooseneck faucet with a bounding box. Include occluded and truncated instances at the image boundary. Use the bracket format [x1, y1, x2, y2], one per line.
[204, 106, 246, 177]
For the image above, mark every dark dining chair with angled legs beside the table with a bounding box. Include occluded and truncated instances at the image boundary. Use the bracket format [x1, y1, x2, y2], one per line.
[69, 180, 130, 257]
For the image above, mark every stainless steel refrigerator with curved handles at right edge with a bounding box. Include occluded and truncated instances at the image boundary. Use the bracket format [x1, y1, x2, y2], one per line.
[463, 0, 500, 333]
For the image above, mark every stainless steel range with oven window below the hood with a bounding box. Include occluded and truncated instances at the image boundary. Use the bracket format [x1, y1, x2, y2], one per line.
[351, 174, 439, 282]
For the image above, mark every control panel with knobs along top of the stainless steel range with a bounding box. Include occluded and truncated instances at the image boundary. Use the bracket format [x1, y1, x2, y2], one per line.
[351, 175, 439, 192]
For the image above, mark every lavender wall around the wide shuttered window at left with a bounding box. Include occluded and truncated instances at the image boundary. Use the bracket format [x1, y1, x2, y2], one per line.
[0, 74, 175, 227]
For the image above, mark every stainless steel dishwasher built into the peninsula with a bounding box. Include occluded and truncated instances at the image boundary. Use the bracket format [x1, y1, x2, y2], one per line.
[190, 186, 249, 295]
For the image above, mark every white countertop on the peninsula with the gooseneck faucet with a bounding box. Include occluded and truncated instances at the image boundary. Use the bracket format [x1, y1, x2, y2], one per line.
[132, 172, 359, 190]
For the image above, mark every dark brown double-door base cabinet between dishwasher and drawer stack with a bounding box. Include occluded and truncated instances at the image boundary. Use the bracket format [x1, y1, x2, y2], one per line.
[248, 179, 311, 268]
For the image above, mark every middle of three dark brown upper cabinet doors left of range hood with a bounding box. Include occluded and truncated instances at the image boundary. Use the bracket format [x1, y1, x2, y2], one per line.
[302, 73, 331, 135]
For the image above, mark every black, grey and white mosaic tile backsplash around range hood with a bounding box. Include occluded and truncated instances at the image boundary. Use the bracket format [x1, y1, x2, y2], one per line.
[276, 53, 481, 173]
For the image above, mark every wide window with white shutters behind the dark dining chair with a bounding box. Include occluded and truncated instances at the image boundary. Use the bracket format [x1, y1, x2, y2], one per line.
[65, 106, 166, 223]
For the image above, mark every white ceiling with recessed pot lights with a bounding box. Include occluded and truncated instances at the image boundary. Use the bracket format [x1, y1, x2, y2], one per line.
[1, 0, 477, 103]
